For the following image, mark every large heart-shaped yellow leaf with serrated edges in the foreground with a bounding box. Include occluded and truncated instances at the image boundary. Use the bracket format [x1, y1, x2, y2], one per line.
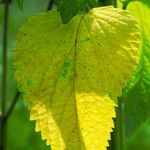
[14, 7, 141, 150]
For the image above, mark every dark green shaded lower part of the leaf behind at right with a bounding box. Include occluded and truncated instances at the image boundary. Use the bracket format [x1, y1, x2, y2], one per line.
[124, 79, 150, 137]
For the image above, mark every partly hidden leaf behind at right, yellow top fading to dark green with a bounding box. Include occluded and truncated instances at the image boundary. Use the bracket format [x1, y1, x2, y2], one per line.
[120, 0, 150, 137]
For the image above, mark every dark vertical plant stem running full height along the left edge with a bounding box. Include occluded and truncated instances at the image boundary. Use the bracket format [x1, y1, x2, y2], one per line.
[0, 0, 9, 150]
